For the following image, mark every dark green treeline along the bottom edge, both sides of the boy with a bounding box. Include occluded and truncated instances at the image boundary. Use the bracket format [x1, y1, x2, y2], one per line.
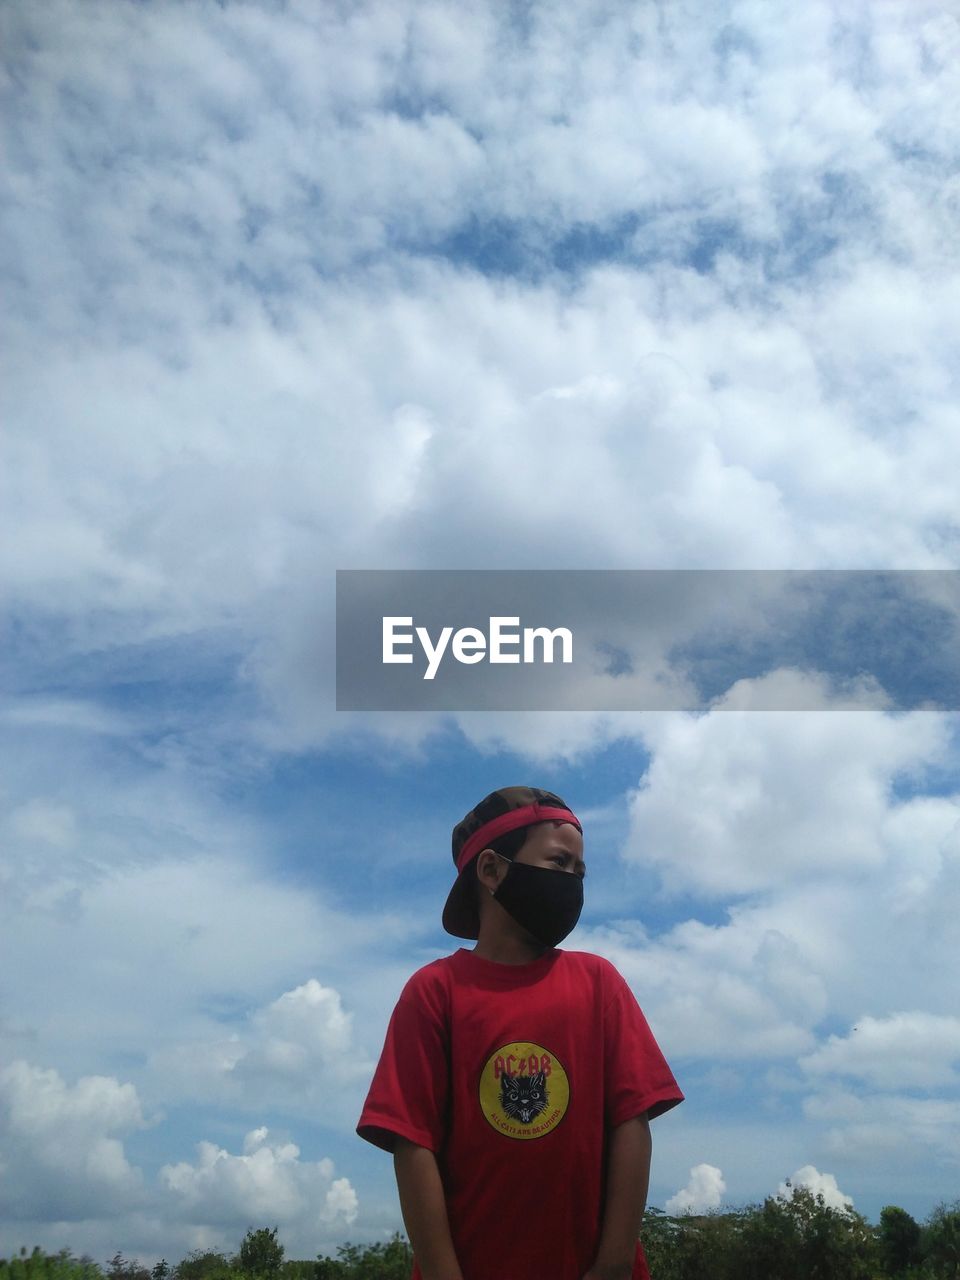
[0, 1188, 960, 1280]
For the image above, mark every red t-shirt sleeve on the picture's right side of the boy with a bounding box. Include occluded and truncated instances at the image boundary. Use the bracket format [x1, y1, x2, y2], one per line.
[603, 965, 684, 1129]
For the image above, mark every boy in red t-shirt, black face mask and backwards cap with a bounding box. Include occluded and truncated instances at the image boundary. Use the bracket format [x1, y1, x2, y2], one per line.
[357, 787, 684, 1280]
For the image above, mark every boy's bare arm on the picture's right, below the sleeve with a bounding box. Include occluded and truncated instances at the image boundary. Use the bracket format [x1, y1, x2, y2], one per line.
[584, 1115, 652, 1280]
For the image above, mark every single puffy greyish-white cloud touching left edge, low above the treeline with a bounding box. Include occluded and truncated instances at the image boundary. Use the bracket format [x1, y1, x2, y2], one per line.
[0, 1060, 145, 1221]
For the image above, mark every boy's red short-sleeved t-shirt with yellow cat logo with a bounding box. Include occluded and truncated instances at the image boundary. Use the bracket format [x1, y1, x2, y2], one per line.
[357, 948, 684, 1280]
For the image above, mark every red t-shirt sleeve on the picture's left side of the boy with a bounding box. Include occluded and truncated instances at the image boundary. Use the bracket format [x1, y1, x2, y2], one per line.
[357, 974, 449, 1152]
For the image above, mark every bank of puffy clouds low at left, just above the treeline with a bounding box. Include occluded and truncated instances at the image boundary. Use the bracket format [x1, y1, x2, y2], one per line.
[0, 1060, 358, 1251]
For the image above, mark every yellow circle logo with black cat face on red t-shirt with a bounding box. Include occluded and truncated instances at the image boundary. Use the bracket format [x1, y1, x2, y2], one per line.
[480, 1041, 570, 1140]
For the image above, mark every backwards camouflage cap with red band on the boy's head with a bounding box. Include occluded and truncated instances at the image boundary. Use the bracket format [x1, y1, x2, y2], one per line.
[443, 787, 582, 938]
